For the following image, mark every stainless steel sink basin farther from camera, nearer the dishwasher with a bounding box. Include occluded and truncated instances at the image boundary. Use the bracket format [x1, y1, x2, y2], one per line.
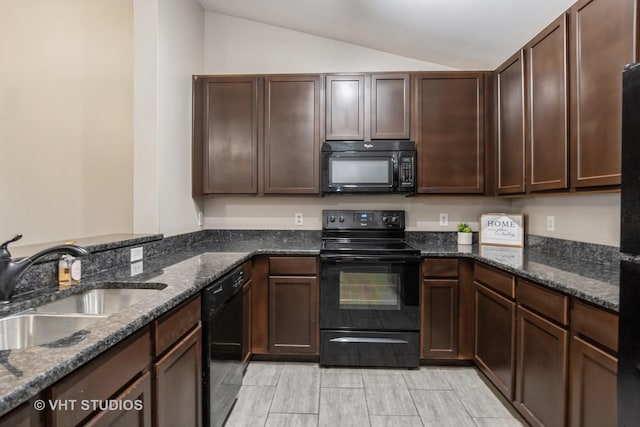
[35, 288, 158, 315]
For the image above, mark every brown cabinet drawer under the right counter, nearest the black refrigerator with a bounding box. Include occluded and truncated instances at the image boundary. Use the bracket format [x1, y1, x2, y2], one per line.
[571, 300, 618, 352]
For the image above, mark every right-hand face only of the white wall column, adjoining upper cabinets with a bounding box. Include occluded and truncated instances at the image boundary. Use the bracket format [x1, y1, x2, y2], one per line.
[157, 0, 204, 236]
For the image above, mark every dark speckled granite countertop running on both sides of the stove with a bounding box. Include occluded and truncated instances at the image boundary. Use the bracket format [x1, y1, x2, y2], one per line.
[0, 232, 618, 415]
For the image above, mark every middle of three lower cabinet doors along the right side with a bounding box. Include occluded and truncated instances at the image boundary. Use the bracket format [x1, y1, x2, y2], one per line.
[515, 306, 569, 427]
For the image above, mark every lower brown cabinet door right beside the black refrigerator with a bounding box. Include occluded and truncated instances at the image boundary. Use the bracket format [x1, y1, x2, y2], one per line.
[569, 336, 618, 427]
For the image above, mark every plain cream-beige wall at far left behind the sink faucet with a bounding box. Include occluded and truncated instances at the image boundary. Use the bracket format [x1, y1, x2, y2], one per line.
[0, 0, 133, 244]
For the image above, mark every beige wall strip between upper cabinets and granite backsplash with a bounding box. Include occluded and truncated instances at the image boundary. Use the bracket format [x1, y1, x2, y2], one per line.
[204, 194, 620, 246]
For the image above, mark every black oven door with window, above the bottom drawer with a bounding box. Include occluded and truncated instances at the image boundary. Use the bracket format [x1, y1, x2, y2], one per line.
[320, 254, 420, 331]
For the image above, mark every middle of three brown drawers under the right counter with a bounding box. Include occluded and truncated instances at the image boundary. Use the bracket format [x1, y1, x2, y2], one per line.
[516, 279, 569, 325]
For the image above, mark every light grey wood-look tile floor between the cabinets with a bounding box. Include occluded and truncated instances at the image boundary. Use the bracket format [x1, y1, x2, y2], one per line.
[226, 362, 526, 427]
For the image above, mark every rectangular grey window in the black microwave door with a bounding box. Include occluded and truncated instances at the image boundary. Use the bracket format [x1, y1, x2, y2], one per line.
[330, 158, 393, 185]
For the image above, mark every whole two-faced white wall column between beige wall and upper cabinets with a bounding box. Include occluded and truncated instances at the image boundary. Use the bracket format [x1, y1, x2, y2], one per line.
[134, 0, 204, 236]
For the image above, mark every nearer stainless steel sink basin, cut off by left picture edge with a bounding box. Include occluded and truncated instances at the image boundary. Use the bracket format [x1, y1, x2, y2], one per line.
[0, 313, 106, 351]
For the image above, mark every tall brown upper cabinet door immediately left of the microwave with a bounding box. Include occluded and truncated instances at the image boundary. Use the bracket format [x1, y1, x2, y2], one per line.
[264, 74, 321, 194]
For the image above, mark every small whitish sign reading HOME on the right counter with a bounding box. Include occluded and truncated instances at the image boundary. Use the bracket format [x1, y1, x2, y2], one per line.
[478, 213, 524, 247]
